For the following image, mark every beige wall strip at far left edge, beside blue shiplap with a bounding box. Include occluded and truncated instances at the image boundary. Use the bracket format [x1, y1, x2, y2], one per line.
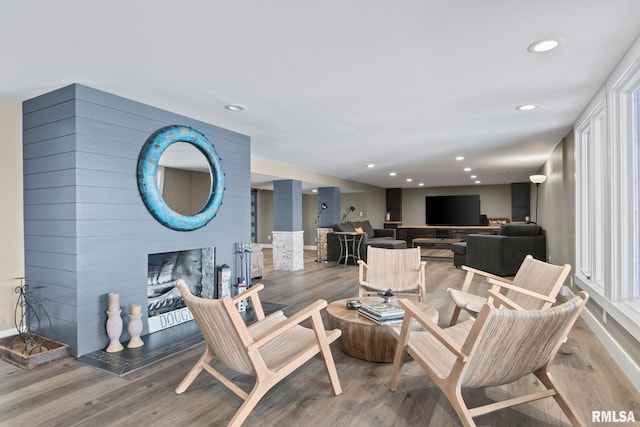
[0, 99, 24, 335]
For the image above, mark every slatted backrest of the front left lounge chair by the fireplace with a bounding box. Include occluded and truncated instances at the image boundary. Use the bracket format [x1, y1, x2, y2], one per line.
[177, 279, 254, 375]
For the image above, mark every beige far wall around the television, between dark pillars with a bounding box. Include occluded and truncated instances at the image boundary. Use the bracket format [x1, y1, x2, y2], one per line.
[402, 184, 511, 226]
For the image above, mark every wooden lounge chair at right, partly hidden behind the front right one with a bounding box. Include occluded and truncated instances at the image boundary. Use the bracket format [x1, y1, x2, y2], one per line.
[447, 255, 571, 326]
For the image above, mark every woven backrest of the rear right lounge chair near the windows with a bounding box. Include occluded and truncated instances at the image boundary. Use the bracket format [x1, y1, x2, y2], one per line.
[505, 255, 571, 310]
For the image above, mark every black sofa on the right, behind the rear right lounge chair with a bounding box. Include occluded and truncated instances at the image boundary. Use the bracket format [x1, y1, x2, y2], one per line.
[451, 224, 547, 276]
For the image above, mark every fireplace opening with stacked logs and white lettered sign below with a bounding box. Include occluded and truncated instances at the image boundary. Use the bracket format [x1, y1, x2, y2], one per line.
[147, 248, 215, 333]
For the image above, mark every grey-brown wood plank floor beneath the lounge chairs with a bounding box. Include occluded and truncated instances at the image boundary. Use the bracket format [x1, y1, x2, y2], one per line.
[0, 250, 640, 427]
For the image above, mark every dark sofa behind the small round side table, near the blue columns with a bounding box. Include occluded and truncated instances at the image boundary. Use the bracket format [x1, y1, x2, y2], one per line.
[327, 221, 406, 262]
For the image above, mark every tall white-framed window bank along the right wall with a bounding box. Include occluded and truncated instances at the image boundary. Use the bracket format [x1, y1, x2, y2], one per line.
[575, 46, 640, 340]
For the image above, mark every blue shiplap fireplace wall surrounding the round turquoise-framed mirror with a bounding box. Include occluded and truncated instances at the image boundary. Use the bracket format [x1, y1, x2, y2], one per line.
[23, 84, 251, 356]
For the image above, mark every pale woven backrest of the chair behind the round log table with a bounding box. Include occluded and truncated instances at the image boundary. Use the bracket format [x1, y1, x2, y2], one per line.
[366, 246, 424, 292]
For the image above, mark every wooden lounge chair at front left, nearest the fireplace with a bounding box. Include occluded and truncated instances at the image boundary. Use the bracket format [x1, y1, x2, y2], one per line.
[176, 279, 342, 426]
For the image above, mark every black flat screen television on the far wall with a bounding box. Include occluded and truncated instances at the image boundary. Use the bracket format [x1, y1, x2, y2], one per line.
[425, 194, 481, 225]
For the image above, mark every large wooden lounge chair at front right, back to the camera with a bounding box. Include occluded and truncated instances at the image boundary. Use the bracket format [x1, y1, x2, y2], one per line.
[389, 292, 588, 426]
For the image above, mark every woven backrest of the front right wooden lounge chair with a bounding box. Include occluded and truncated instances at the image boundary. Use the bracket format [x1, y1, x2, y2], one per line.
[461, 292, 588, 387]
